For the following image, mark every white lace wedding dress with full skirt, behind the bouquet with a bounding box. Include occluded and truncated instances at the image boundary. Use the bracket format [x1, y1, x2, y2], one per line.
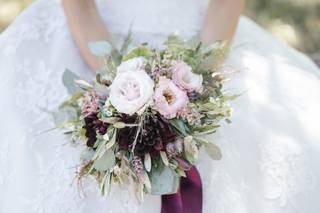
[0, 0, 320, 213]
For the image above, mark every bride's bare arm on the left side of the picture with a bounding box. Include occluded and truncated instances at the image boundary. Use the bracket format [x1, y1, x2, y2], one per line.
[62, 0, 111, 70]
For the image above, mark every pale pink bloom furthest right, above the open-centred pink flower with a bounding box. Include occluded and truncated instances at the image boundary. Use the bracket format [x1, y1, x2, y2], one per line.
[171, 61, 203, 92]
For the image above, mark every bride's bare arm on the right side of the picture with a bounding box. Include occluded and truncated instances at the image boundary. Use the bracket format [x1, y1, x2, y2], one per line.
[200, 0, 245, 43]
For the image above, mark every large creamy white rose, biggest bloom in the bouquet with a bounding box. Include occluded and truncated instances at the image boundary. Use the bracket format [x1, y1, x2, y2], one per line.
[109, 70, 154, 115]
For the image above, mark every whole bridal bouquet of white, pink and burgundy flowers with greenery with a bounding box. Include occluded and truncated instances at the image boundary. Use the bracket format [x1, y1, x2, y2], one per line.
[59, 36, 235, 198]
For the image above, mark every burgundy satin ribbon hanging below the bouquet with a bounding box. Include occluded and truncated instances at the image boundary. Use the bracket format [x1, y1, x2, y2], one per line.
[161, 167, 202, 213]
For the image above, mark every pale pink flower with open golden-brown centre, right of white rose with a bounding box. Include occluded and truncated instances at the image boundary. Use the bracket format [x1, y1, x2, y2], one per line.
[154, 77, 189, 119]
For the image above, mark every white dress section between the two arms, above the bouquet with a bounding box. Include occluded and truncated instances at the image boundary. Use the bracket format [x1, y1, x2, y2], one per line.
[98, 0, 207, 45]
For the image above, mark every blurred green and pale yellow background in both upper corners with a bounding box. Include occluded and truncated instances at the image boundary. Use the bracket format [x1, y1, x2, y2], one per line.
[0, 0, 320, 65]
